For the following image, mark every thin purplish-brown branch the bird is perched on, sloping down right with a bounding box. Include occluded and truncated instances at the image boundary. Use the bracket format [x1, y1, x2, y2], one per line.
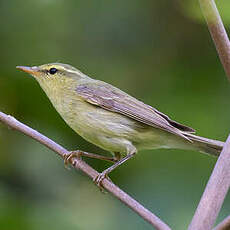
[0, 112, 170, 230]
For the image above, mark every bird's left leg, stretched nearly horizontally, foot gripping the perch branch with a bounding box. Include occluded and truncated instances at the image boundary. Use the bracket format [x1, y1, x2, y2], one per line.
[63, 150, 119, 167]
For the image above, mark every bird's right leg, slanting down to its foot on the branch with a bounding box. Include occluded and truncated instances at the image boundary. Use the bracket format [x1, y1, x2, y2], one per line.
[94, 150, 136, 191]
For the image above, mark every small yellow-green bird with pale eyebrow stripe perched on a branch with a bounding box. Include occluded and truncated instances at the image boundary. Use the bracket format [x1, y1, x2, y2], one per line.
[16, 63, 224, 187]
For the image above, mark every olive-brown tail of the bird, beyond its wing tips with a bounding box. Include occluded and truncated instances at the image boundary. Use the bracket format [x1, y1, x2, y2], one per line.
[185, 133, 224, 156]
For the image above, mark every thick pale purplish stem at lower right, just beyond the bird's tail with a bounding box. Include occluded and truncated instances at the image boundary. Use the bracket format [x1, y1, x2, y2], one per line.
[188, 135, 230, 230]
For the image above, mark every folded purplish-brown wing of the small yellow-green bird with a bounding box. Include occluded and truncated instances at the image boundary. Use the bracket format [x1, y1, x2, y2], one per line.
[76, 81, 195, 140]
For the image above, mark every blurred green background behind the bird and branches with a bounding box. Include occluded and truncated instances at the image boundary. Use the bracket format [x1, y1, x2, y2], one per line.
[0, 0, 230, 230]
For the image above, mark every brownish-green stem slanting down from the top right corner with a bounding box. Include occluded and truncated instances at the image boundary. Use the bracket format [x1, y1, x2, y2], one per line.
[199, 0, 230, 80]
